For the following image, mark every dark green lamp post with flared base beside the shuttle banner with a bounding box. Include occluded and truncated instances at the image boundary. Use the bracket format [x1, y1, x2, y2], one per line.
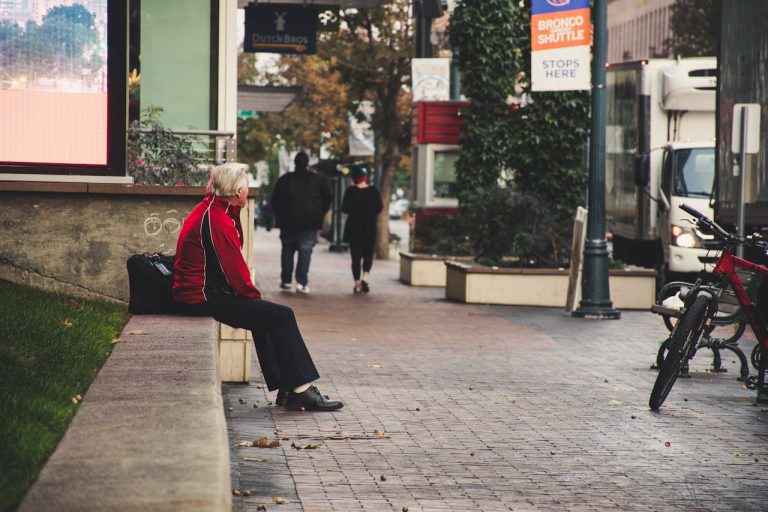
[573, 0, 621, 319]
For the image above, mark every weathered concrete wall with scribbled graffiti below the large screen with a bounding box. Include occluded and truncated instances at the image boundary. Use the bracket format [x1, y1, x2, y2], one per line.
[0, 182, 254, 301]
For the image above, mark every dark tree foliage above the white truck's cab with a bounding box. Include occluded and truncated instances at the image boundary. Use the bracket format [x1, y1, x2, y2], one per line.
[664, 0, 721, 57]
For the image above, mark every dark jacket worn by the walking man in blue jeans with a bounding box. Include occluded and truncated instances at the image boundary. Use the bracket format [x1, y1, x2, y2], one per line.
[272, 169, 332, 231]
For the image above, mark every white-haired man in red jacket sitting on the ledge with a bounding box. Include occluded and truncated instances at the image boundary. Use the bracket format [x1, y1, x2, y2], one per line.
[173, 163, 344, 411]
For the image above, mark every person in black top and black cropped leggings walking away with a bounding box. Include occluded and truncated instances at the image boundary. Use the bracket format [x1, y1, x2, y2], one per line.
[341, 167, 383, 295]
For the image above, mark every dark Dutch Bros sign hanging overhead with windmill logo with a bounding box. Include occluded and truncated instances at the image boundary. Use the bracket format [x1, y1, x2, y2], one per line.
[243, 4, 317, 55]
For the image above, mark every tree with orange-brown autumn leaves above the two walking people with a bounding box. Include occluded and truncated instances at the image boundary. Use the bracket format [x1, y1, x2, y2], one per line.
[238, 0, 413, 258]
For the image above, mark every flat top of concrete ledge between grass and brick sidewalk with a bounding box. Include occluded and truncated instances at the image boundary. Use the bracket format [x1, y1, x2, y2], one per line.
[18, 316, 232, 512]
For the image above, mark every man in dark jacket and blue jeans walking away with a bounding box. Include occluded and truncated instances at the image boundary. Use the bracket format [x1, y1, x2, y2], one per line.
[272, 151, 332, 293]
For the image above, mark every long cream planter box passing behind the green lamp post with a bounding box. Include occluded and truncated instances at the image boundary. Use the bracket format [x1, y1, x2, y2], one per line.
[445, 261, 656, 309]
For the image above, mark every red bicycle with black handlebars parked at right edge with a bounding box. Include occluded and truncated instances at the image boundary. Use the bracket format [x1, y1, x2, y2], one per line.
[648, 204, 768, 411]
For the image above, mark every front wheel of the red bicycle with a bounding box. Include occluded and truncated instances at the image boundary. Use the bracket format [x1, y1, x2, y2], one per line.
[648, 295, 710, 411]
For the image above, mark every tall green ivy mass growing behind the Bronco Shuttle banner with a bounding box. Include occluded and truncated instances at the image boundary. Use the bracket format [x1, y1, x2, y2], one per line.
[450, 0, 590, 266]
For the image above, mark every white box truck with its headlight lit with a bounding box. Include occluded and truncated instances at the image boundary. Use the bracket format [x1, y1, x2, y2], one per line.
[605, 58, 717, 281]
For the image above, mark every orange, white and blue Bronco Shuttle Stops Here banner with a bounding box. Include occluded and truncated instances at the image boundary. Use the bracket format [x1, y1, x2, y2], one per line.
[531, 0, 592, 91]
